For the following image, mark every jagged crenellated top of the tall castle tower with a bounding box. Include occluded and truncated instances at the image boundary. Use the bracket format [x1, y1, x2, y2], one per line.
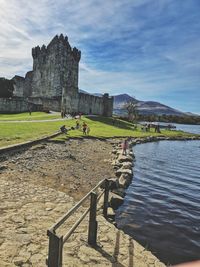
[32, 34, 81, 62]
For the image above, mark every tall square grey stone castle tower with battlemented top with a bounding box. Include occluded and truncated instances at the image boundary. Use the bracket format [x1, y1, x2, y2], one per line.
[32, 34, 81, 105]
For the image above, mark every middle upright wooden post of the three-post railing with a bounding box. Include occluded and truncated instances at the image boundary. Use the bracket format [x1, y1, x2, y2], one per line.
[88, 192, 97, 246]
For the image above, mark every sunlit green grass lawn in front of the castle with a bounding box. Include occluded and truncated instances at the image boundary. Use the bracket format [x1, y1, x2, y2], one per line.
[0, 112, 197, 147]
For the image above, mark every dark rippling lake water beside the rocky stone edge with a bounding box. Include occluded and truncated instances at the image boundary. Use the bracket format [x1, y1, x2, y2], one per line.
[116, 141, 200, 264]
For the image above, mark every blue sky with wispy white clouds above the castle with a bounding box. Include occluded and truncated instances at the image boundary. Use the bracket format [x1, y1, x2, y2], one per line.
[0, 0, 200, 114]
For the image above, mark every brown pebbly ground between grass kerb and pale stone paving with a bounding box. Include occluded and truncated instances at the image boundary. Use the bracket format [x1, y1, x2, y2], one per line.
[0, 139, 115, 200]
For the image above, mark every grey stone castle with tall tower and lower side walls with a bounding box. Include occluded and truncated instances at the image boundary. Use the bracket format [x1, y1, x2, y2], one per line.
[5, 34, 113, 116]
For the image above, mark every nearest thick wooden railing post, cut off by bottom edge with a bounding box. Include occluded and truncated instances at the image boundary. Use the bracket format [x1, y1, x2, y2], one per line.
[47, 230, 63, 267]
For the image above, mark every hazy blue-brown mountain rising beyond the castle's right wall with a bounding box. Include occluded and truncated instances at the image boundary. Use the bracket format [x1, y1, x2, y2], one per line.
[114, 94, 188, 116]
